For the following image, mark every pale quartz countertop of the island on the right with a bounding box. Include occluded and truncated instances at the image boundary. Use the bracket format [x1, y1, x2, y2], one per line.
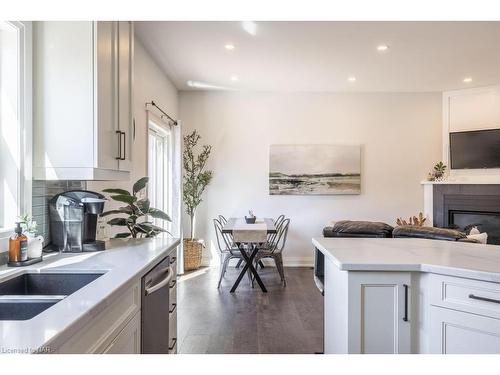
[312, 238, 500, 282]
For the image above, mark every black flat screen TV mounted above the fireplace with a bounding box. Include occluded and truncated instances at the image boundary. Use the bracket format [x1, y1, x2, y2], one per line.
[450, 129, 500, 169]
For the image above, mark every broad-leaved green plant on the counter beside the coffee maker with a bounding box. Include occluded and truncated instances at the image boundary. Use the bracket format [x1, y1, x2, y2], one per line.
[101, 177, 172, 238]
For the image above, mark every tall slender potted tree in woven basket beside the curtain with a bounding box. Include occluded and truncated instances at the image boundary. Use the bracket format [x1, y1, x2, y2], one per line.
[182, 130, 212, 270]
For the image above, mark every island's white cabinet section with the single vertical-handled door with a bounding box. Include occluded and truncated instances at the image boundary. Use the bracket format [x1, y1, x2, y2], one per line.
[325, 260, 411, 354]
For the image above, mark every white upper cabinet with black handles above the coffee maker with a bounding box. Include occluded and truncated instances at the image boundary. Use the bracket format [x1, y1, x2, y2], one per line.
[33, 21, 133, 180]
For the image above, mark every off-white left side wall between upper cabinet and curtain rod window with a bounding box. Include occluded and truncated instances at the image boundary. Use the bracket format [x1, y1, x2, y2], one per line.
[87, 37, 178, 235]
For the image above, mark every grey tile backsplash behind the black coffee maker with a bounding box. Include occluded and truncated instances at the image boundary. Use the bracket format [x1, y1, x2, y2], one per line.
[32, 180, 87, 246]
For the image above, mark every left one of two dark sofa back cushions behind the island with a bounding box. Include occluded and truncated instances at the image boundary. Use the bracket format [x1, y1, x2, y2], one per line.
[323, 220, 393, 238]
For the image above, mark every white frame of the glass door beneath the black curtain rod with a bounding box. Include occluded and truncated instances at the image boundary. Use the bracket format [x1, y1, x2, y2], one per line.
[147, 118, 173, 231]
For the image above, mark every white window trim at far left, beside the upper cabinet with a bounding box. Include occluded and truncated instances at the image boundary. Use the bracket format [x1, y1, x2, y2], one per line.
[0, 21, 33, 242]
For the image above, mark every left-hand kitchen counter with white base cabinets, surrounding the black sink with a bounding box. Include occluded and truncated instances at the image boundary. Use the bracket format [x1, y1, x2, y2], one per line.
[0, 238, 180, 353]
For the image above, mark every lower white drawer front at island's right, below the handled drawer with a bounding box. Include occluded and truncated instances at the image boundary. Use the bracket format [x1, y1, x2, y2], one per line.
[429, 306, 500, 354]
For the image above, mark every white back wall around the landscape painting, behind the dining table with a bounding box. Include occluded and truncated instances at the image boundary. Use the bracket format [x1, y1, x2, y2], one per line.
[179, 91, 441, 265]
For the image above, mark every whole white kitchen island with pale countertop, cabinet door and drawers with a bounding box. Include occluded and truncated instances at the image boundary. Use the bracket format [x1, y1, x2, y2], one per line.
[312, 238, 500, 353]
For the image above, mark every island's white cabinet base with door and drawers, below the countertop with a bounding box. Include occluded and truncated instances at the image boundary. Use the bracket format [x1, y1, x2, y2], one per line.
[324, 259, 500, 354]
